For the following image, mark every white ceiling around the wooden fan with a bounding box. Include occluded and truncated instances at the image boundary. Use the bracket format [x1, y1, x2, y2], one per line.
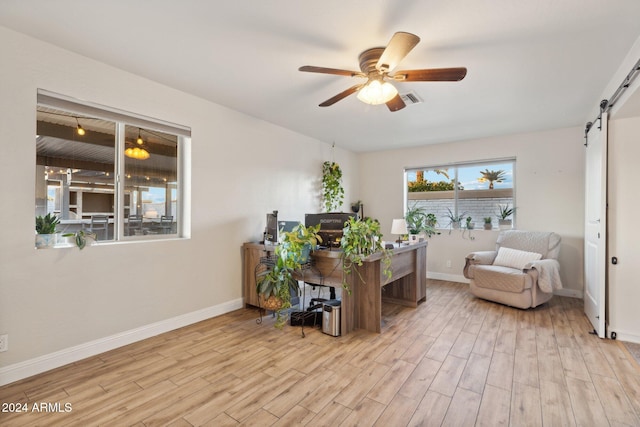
[0, 0, 640, 151]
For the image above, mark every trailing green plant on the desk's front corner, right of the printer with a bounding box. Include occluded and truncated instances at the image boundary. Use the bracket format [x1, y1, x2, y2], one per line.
[340, 217, 391, 293]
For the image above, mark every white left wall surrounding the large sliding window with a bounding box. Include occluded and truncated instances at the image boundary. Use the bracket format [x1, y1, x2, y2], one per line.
[0, 27, 358, 385]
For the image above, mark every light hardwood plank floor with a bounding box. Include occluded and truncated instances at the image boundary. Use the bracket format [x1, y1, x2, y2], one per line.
[0, 280, 640, 427]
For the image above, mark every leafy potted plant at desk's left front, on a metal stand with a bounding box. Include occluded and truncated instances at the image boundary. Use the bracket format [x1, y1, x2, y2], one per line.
[256, 224, 322, 328]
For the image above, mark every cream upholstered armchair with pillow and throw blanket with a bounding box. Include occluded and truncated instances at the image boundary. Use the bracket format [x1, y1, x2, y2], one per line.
[464, 230, 562, 309]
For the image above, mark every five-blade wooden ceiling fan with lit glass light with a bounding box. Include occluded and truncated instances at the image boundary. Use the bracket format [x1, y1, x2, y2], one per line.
[298, 32, 467, 111]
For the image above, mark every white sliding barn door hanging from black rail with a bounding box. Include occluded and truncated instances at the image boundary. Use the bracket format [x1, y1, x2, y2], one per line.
[584, 112, 607, 338]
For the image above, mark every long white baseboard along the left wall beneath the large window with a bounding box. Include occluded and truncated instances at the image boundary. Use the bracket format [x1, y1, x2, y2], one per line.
[0, 298, 243, 386]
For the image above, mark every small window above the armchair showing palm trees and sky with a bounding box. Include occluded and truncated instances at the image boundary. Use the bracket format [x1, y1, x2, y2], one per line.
[405, 159, 515, 228]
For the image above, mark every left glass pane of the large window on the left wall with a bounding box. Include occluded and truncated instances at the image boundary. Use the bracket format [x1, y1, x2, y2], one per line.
[35, 106, 116, 240]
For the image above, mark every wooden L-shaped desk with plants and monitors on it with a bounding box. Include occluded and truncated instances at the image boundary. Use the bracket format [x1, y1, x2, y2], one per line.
[242, 242, 427, 335]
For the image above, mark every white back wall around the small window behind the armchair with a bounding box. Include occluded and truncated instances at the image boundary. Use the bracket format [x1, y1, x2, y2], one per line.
[360, 128, 584, 297]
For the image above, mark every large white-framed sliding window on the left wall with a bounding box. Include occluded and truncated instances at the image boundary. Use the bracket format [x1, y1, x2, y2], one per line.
[35, 90, 191, 246]
